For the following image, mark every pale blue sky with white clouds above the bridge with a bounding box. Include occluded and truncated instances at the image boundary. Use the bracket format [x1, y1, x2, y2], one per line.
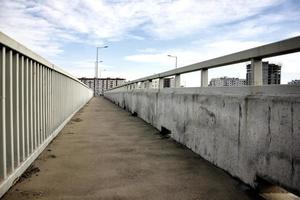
[0, 0, 300, 86]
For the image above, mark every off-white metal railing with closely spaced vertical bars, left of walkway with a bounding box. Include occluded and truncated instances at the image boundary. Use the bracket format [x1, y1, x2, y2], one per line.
[0, 32, 93, 197]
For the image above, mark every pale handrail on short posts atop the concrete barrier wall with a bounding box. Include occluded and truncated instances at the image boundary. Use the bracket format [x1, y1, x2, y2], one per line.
[107, 36, 300, 92]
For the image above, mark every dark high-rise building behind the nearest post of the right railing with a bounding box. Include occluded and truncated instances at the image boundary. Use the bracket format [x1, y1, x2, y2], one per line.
[246, 62, 281, 85]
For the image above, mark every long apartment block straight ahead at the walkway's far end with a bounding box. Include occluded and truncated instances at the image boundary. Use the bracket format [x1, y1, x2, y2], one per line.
[79, 77, 125, 96]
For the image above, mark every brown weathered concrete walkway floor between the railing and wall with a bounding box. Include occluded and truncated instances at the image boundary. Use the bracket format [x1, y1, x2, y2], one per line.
[3, 98, 258, 200]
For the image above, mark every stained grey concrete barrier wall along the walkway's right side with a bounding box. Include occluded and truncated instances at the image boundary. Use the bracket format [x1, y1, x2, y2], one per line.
[105, 85, 300, 193]
